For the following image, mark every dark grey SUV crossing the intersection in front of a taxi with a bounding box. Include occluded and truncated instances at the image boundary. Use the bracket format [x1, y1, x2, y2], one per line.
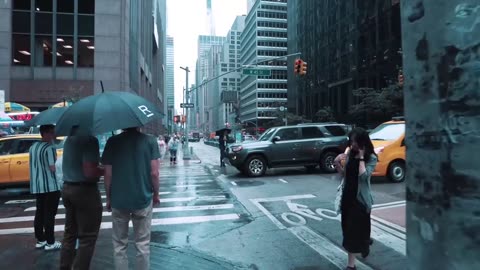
[227, 123, 348, 177]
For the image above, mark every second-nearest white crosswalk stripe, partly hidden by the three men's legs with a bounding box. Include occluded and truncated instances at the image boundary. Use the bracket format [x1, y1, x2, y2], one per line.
[0, 204, 234, 224]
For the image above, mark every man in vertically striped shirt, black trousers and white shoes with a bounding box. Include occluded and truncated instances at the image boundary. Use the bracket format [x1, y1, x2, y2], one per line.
[29, 125, 62, 250]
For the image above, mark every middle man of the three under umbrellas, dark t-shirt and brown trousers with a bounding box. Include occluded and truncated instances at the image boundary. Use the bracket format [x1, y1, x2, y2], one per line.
[60, 130, 103, 270]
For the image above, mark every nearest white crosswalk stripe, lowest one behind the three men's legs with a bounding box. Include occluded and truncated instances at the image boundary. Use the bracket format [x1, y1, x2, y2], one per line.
[0, 214, 240, 235]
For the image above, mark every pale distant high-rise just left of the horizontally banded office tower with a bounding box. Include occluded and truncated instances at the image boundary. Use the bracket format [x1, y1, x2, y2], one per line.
[194, 35, 225, 132]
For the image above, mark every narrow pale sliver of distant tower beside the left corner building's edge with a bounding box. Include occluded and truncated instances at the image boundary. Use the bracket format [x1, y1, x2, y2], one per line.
[165, 36, 175, 134]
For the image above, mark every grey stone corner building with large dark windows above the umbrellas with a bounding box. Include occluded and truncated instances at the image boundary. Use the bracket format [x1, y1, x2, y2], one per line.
[0, 0, 166, 133]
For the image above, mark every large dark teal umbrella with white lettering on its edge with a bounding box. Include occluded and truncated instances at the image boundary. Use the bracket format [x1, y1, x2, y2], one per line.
[55, 91, 161, 136]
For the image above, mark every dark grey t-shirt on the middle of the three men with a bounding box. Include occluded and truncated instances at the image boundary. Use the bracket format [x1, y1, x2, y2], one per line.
[62, 136, 100, 182]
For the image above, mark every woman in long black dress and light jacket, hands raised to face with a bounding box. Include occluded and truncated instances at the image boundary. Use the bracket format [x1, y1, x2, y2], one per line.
[336, 128, 377, 270]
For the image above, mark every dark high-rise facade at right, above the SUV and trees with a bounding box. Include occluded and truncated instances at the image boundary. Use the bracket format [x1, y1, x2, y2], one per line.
[288, 0, 402, 121]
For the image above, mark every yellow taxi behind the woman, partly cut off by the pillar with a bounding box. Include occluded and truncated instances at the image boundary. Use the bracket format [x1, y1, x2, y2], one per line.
[370, 117, 406, 183]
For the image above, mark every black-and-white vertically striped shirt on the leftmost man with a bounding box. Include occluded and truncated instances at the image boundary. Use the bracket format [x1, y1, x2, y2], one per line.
[29, 142, 60, 194]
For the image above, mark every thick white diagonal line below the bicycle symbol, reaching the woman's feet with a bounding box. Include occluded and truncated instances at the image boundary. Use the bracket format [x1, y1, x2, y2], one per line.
[288, 226, 372, 270]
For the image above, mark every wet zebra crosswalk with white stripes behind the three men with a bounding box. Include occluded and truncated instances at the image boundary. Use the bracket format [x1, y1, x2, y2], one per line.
[0, 164, 241, 235]
